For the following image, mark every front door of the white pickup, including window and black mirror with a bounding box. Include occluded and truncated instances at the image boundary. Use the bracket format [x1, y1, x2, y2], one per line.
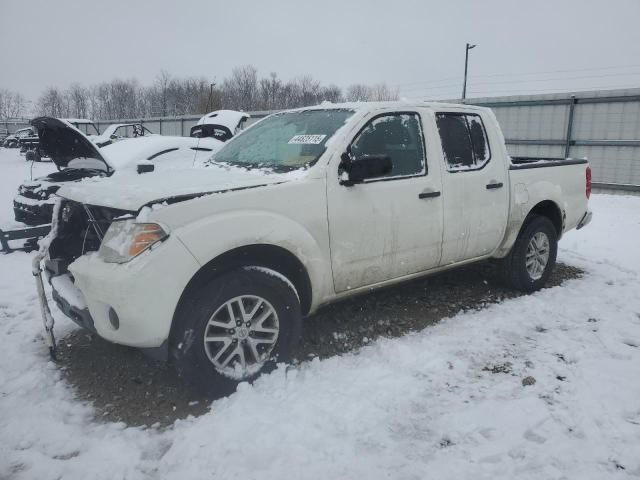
[327, 111, 442, 292]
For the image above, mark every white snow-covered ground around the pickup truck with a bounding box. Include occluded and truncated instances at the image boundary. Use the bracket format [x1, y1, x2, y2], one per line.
[0, 149, 640, 480]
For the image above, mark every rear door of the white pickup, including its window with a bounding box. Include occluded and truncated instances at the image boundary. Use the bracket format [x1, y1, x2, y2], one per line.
[436, 111, 509, 265]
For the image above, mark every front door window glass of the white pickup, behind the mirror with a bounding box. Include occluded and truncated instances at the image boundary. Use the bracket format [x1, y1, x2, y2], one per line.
[351, 113, 426, 178]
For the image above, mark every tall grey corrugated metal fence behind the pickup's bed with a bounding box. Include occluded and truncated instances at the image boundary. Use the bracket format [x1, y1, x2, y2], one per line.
[467, 88, 640, 185]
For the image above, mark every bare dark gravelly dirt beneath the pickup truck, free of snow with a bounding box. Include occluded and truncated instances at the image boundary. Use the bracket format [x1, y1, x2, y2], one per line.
[58, 263, 583, 427]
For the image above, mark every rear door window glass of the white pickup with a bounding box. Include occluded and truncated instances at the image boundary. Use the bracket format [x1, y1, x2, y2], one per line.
[436, 113, 491, 172]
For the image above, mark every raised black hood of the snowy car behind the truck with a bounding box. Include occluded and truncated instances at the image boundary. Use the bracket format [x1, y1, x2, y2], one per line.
[31, 117, 113, 172]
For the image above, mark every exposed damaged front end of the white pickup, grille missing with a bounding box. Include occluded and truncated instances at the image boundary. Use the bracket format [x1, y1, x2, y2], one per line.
[33, 198, 131, 358]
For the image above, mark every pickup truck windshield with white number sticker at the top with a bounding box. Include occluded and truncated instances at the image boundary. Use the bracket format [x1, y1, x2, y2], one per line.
[212, 109, 353, 170]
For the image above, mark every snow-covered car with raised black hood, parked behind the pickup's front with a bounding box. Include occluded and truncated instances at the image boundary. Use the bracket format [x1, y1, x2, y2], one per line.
[13, 117, 223, 225]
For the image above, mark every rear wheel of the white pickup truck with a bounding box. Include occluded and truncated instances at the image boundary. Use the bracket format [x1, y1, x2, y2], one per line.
[498, 215, 558, 292]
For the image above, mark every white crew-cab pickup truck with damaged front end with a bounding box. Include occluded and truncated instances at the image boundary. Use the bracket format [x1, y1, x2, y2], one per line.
[35, 103, 591, 392]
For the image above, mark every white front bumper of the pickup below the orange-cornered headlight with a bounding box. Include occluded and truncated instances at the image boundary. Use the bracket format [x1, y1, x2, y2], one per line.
[61, 236, 200, 348]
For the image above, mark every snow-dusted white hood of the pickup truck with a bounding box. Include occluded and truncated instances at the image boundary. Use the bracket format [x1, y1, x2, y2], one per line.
[58, 165, 305, 212]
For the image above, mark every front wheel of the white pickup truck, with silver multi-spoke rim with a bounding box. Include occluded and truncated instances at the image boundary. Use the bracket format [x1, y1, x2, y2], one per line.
[169, 267, 302, 397]
